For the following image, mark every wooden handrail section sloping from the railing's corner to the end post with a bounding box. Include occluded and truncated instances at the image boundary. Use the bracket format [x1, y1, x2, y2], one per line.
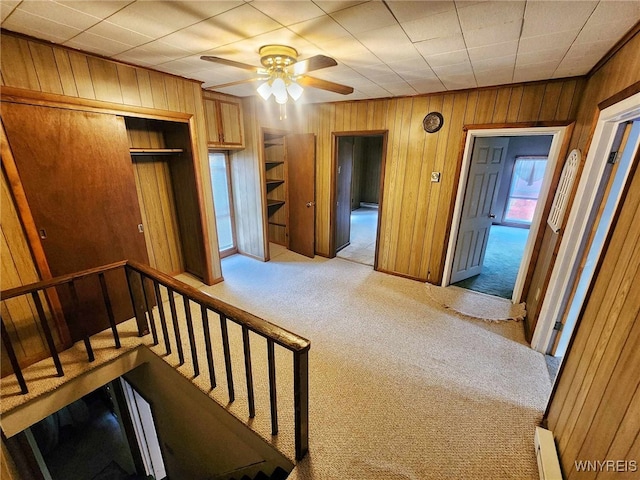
[127, 260, 311, 352]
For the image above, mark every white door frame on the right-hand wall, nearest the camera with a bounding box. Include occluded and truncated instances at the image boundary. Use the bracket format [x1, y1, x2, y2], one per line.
[531, 92, 640, 353]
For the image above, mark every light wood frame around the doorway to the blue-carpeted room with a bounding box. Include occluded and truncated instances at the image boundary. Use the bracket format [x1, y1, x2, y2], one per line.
[441, 123, 572, 303]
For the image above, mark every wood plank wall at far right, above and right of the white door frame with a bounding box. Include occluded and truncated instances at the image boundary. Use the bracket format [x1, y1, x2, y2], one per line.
[539, 29, 640, 479]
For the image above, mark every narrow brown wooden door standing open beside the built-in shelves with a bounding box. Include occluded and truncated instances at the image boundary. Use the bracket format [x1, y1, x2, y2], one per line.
[285, 133, 316, 258]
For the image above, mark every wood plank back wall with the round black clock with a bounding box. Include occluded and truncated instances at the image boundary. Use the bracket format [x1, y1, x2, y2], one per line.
[251, 79, 584, 283]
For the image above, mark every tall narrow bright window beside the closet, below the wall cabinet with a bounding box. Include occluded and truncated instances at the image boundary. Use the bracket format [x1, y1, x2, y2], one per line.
[209, 152, 236, 257]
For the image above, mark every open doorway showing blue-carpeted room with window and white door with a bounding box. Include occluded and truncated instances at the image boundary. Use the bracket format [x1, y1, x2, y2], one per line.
[451, 135, 553, 299]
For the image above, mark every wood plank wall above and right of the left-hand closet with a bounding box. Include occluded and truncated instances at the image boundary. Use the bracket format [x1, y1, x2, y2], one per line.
[0, 31, 222, 279]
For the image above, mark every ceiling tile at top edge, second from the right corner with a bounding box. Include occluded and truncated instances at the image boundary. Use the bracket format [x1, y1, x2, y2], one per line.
[522, 1, 598, 37]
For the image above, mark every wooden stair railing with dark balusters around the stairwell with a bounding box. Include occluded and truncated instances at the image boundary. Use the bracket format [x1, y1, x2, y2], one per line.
[0, 261, 311, 460]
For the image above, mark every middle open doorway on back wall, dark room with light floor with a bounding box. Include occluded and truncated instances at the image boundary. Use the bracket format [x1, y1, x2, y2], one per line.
[333, 132, 385, 267]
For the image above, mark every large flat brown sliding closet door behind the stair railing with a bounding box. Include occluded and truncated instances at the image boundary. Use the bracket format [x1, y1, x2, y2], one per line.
[2, 102, 148, 341]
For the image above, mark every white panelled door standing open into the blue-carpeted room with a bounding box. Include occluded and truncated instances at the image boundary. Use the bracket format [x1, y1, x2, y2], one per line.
[451, 137, 509, 283]
